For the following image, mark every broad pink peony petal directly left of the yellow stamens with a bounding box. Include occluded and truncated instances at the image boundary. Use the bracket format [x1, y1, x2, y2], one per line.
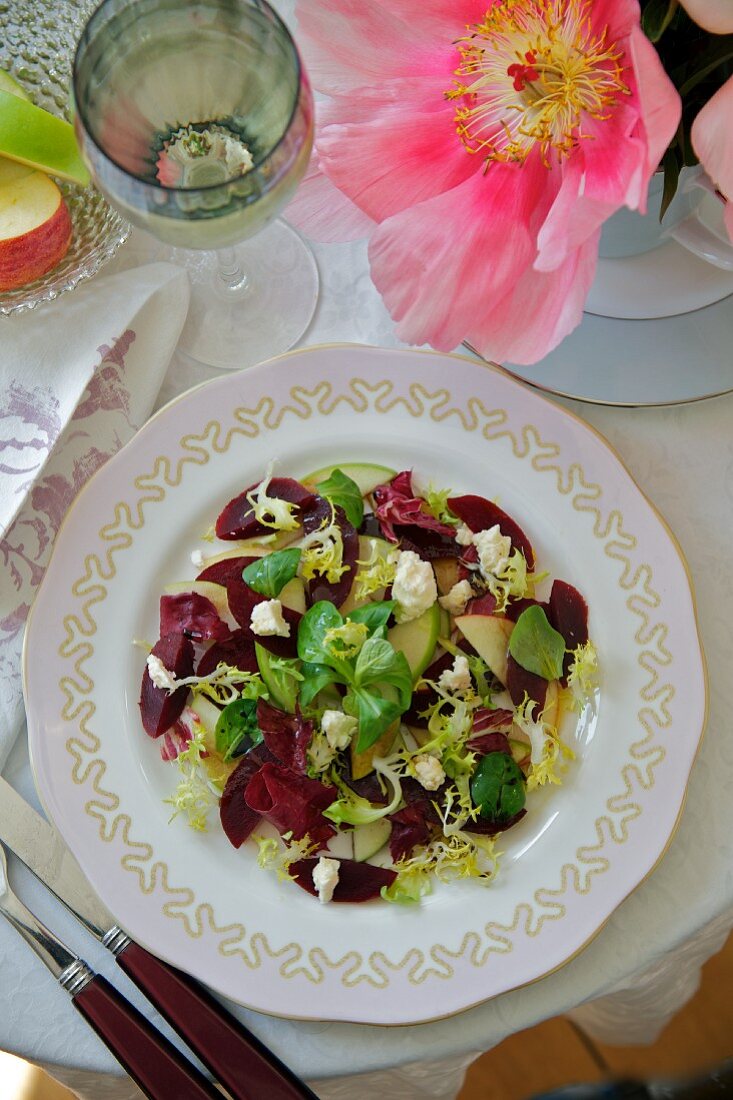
[317, 81, 477, 222]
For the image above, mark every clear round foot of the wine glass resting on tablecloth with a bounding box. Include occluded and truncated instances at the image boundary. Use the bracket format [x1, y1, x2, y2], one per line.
[176, 221, 318, 371]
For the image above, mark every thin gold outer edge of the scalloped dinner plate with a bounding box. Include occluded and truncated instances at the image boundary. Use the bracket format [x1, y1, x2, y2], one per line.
[22, 341, 710, 1026]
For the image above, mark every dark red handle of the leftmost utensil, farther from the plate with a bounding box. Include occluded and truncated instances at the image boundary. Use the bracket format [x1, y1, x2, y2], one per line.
[74, 975, 221, 1100]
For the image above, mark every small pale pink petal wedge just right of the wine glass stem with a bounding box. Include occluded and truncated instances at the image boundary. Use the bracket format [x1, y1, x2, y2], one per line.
[285, 158, 374, 244]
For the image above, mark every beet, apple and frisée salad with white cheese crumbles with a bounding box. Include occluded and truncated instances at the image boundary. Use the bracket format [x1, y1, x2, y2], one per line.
[140, 463, 598, 903]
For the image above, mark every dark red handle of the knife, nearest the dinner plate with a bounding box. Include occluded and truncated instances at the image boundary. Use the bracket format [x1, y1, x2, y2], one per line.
[117, 943, 318, 1100]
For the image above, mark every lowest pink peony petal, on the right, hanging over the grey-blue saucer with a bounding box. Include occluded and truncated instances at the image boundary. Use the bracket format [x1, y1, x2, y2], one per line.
[466, 236, 600, 364]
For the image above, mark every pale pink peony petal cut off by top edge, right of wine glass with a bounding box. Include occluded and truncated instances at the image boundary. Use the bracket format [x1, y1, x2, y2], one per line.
[296, 0, 453, 95]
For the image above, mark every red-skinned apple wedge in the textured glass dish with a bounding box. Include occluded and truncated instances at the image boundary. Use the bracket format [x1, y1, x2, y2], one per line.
[0, 169, 72, 290]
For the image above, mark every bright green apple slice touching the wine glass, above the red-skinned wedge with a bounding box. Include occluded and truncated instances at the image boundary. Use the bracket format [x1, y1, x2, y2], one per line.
[0, 87, 89, 186]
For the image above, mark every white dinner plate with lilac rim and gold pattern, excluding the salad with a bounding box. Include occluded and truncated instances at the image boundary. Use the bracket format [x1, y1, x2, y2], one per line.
[24, 345, 705, 1024]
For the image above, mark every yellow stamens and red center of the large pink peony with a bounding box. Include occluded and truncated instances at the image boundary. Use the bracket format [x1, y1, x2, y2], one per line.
[446, 0, 630, 166]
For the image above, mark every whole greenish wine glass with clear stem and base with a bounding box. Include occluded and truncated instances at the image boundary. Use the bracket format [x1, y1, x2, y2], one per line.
[73, 0, 318, 369]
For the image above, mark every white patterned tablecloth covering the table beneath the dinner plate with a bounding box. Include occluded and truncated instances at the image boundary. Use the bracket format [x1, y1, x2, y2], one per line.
[0, 218, 733, 1100]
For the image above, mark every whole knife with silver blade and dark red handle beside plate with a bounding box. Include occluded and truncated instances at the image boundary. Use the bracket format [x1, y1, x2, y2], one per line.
[0, 776, 318, 1100]
